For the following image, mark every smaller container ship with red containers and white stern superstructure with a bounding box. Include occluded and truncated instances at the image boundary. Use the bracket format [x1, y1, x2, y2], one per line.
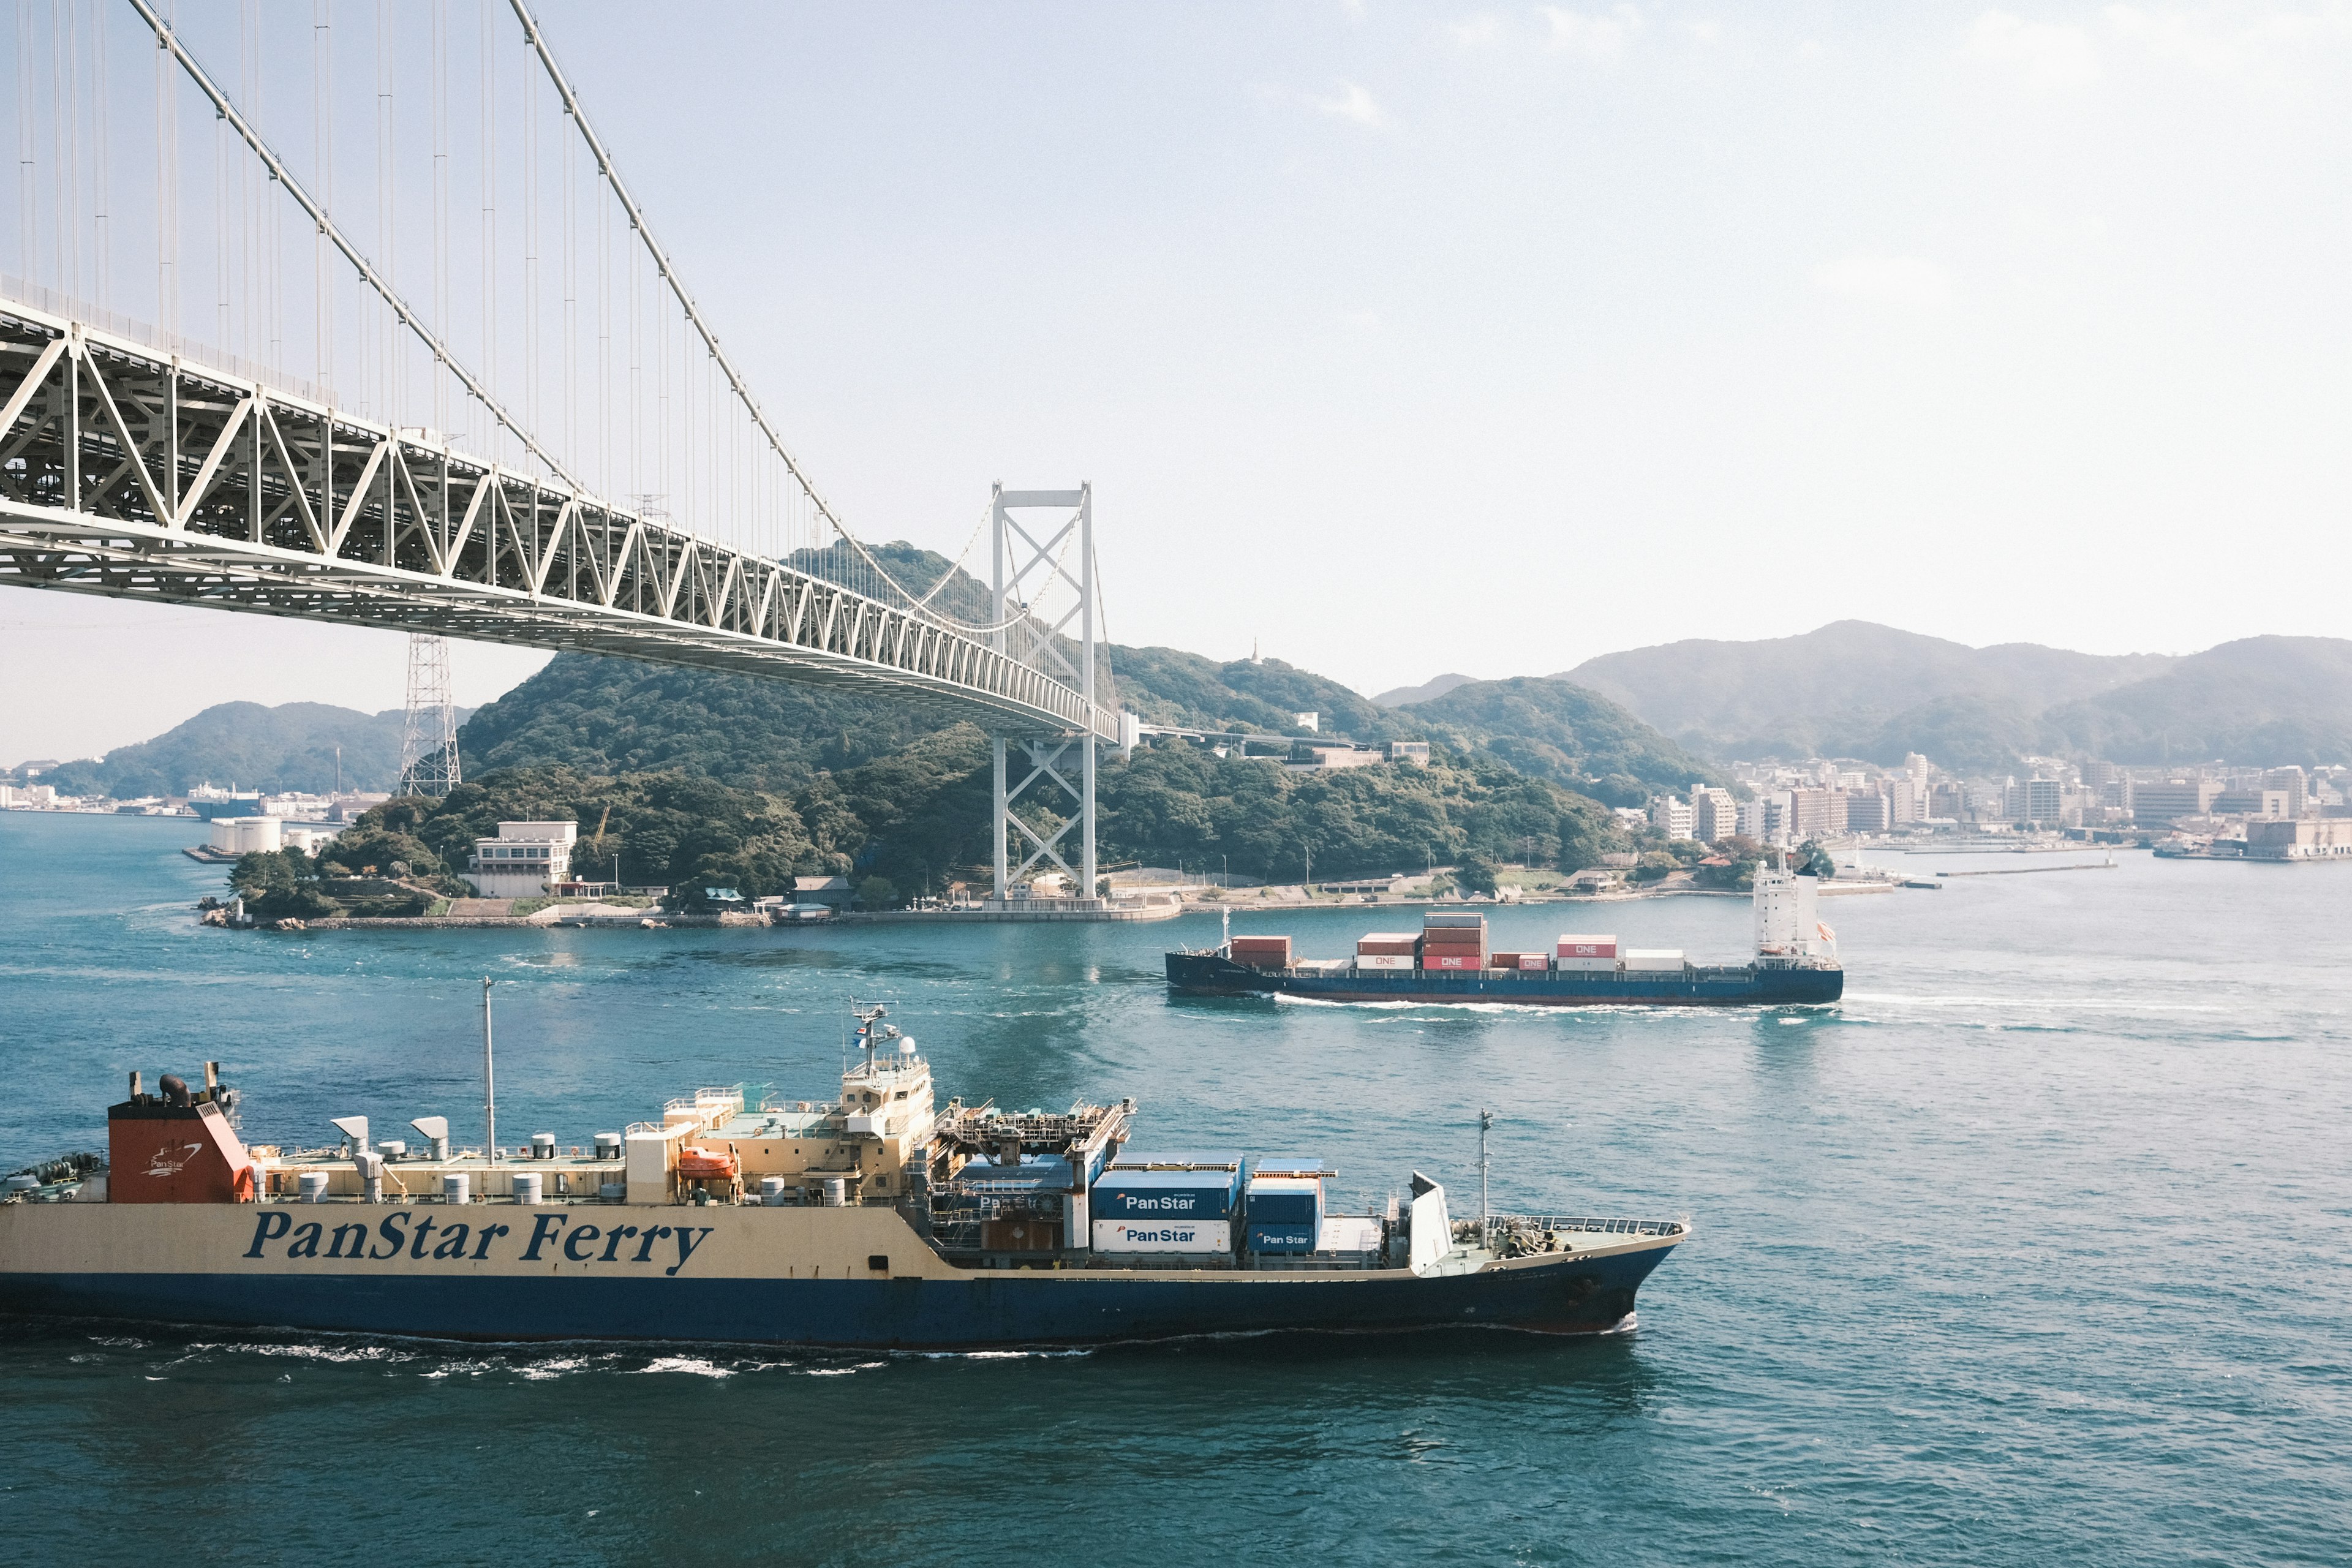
[1167, 867, 1846, 1006]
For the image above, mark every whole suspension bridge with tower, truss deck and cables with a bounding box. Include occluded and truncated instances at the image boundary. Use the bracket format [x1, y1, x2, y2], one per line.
[0, 0, 1136, 905]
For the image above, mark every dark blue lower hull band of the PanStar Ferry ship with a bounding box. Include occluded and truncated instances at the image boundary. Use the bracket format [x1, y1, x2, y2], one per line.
[0, 1243, 1672, 1349]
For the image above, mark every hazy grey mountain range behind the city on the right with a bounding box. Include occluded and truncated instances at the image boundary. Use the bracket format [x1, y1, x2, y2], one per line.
[1559, 620, 2352, 774]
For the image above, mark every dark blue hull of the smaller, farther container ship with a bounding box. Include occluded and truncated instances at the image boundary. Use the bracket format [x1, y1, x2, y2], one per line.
[1167, 952, 1846, 1006]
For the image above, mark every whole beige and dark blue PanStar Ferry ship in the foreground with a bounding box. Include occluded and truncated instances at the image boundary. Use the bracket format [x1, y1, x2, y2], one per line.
[0, 999, 1689, 1349]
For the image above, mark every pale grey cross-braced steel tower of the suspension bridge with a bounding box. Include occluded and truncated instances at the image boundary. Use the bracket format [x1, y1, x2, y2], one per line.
[988, 484, 1103, 907]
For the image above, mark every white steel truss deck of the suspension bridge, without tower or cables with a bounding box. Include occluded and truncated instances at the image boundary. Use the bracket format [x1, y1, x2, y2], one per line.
[0, 298, 1117, 738]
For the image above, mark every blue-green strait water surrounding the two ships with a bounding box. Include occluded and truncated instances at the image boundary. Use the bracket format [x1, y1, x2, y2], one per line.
[0, 813, 2352, 1568]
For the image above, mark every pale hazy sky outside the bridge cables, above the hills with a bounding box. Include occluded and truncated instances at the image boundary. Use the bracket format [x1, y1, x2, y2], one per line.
[0, 0, 2352, 762]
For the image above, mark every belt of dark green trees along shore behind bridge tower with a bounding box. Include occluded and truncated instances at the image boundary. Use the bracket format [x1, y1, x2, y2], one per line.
[331, 724, 1627, 903]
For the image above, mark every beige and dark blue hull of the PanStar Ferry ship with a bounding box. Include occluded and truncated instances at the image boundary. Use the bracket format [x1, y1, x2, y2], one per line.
[0, 1204, 1684, 1349]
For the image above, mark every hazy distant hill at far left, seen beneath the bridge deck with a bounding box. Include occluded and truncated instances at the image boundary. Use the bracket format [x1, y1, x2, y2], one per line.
[42, 703, 451, 799]
